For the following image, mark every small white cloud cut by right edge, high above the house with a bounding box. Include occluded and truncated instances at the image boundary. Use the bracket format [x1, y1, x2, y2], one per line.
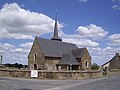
[108, 34, 120, 47]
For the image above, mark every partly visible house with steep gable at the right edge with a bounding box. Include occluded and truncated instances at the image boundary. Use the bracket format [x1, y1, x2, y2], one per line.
[102, 53, 120, 69]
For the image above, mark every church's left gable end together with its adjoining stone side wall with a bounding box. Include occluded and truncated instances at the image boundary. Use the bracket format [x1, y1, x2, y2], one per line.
[28, 38, 60, 70]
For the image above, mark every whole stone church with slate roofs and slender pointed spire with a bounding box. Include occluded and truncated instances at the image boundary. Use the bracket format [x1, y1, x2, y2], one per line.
[28, 14, 91, 70]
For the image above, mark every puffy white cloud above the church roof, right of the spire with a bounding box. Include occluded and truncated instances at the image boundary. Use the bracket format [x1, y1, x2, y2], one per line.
[63, 24, 108, 47]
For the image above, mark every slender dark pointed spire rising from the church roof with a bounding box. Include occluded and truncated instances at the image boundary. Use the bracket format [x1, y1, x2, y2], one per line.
[51, 11, 62, 41]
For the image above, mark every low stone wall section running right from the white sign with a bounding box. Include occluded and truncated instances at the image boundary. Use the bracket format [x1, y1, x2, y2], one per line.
[39, 71, 102, 80]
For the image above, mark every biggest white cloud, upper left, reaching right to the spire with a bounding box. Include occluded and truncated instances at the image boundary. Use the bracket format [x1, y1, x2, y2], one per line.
[0, 3, 63, 39]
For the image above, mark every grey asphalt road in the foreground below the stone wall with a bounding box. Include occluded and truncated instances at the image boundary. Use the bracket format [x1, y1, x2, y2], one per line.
[0, 76, 120, 90]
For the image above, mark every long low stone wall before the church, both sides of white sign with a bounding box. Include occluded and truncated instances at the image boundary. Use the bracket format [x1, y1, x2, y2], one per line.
[0, 69, 102, 80]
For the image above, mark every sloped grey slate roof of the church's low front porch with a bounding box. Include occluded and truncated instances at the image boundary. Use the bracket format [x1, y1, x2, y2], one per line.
[57, 52, 80, 65]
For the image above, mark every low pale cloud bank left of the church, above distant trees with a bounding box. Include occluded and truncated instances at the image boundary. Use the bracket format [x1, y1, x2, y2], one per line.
[0, 42, 31, 64]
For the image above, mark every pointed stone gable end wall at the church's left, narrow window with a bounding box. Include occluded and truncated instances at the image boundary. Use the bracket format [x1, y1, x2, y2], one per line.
[28, 38, 46, 70]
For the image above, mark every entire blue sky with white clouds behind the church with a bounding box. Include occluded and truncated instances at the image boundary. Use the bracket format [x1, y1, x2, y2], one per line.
[0, 0, 120, 65]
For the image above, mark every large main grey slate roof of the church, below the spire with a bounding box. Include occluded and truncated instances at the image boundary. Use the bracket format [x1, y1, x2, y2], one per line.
[37, 37, 78, 57]
